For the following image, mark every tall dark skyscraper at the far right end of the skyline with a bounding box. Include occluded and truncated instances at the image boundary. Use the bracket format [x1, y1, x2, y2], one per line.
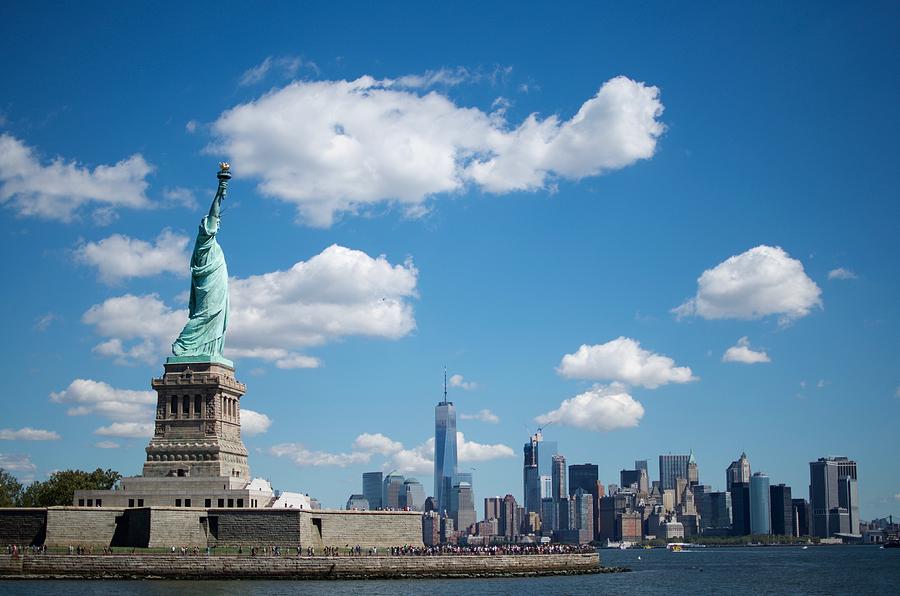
[809, 457, 859, 538]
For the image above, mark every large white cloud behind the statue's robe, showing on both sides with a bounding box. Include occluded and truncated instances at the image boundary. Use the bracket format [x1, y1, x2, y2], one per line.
[82, 245, 418, 369]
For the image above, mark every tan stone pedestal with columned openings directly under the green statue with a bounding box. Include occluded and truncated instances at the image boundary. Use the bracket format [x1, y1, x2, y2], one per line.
[143, 362, 250, 481]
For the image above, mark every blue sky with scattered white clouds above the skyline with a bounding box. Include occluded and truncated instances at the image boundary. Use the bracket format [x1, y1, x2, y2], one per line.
[0, 2, 900, 518]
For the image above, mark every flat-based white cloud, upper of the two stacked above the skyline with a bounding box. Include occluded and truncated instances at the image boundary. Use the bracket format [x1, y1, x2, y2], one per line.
[556, 337, 697, 389]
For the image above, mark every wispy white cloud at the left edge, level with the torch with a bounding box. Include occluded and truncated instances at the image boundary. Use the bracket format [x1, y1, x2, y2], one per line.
[0, 133, 154, 225]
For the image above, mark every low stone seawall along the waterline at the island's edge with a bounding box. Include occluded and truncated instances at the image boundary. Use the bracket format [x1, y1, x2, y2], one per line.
[0, 553, 628, 580]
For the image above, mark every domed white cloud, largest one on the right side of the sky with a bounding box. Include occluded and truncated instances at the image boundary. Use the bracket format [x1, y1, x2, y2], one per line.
[672, 245, 822, 324]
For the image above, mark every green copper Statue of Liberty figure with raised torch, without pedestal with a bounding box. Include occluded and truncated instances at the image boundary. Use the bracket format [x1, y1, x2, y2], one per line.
[167, 162, 234, 366]
